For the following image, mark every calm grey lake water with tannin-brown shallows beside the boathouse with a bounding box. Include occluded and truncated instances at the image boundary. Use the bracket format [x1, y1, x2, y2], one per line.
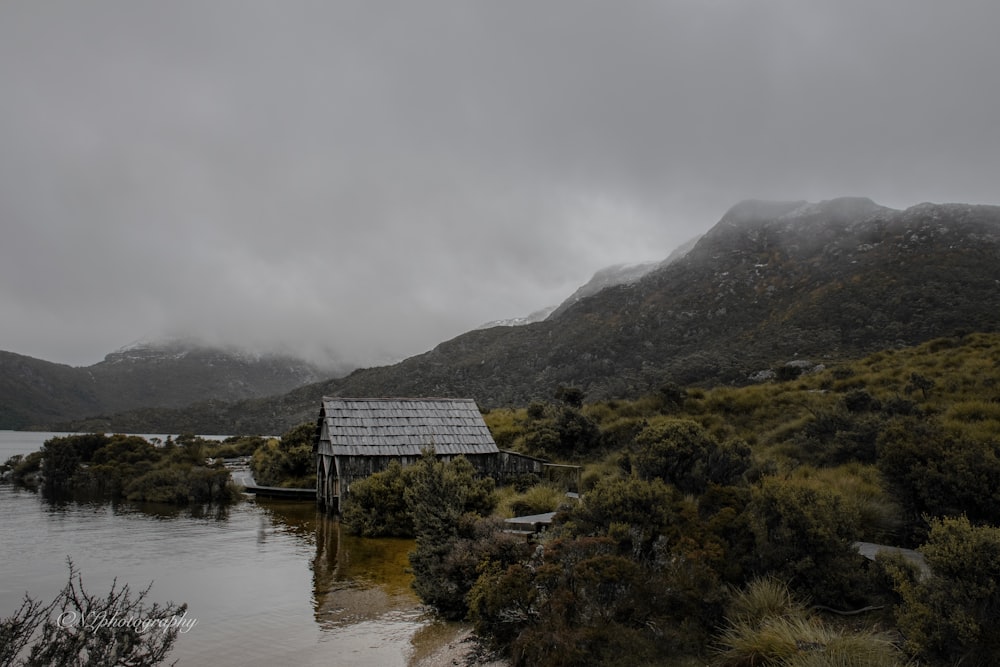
[0, 431, 449, 667]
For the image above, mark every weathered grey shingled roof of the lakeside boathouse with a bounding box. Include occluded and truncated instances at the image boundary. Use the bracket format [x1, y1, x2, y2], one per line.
[320, 396, 499, 456]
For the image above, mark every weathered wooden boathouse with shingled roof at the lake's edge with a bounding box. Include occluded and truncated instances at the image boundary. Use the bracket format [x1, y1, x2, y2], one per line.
[315, 396, 545, 512]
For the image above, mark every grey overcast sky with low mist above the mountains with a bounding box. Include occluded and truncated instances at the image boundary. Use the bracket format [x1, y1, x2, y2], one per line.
[0, 0, 1000, 365]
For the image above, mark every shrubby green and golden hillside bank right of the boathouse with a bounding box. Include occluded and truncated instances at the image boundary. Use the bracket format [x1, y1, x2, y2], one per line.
[344, 334, 1000, 665]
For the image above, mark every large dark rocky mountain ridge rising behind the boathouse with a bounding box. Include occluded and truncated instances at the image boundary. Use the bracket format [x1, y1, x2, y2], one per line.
[52, 198, 1000, 433]
